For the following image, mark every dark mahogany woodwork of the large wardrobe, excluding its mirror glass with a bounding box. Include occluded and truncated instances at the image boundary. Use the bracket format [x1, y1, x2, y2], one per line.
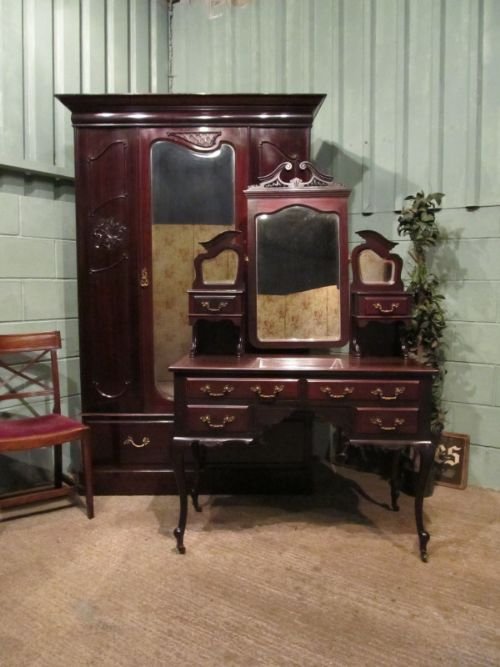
[57, 94, 324, 494]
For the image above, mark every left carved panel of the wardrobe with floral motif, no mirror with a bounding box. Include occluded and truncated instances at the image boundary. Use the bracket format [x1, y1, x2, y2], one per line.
[76, 128, 142, 413]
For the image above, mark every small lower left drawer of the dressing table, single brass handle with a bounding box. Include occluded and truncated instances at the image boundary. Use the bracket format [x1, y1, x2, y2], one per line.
[186, 405, 250, 436]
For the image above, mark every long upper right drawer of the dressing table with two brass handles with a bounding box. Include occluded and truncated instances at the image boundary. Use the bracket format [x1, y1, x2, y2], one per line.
[307, 380, 420, 404]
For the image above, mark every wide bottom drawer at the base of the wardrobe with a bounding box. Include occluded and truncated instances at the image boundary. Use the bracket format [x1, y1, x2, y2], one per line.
[87, 420, 174, 465]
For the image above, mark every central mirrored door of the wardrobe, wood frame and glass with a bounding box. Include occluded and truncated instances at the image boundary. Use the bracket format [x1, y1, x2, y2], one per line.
[141, 127, 248, 410]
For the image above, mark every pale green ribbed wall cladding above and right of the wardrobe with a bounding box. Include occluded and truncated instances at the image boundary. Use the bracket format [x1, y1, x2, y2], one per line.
[173, 0, 500, 213]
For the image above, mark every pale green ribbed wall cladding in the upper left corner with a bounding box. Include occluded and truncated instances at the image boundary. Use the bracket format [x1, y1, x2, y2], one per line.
[0, 0, 171, 183]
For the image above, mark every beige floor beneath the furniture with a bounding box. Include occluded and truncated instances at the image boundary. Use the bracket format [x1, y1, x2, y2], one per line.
[0, 469, 500, 667]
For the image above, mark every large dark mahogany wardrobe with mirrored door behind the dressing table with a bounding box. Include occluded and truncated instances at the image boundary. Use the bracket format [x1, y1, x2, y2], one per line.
[58, 95, 324, 494]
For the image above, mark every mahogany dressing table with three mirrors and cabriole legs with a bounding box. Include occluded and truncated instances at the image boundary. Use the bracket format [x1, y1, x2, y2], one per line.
[170, 161, 435, 561]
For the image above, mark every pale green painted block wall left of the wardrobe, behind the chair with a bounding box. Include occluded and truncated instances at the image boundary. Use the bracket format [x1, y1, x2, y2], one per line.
[0, 193, 80, 492]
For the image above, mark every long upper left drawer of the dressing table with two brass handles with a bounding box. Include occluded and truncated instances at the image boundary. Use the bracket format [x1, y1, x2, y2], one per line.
[186, 378, 299, 403]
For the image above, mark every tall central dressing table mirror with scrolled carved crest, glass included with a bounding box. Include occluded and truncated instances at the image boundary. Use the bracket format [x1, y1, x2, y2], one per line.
[245, 162, 350, 349]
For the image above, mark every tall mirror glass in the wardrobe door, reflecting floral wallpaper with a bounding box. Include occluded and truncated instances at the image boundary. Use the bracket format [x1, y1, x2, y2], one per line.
[150, 140, 236, 395]
